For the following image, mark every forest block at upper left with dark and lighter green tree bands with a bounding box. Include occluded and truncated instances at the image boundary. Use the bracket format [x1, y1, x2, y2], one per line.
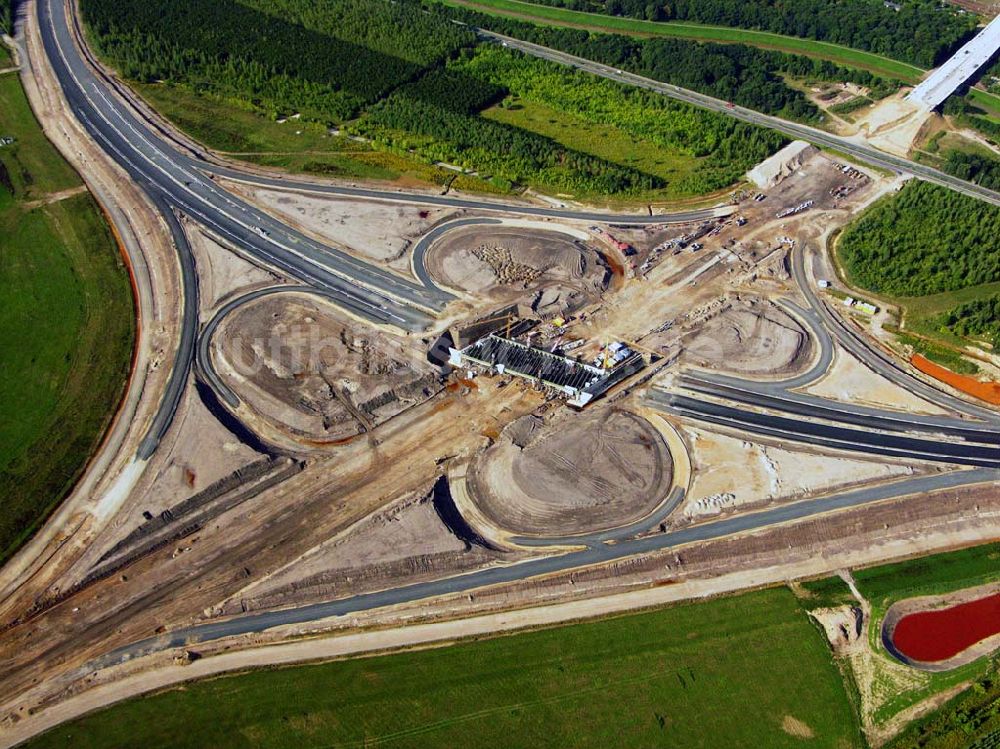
[81, 0, 474, 121]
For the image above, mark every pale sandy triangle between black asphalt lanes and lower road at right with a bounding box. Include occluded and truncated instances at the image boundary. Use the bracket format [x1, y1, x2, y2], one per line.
[680, 424, 917, 518]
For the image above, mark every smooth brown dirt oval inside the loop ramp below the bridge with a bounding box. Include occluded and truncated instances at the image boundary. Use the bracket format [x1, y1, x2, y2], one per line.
[469, 408, 671, 536]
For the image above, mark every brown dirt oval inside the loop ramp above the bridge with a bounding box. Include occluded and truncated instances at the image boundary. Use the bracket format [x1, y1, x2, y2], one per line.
[427, 226, 610, 316]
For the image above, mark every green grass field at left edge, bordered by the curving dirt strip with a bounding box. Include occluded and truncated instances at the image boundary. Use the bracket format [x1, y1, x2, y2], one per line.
[0, 75, 135, 561]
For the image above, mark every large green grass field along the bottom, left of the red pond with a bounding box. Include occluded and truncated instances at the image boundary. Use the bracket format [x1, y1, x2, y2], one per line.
[28, 588, 861, 749]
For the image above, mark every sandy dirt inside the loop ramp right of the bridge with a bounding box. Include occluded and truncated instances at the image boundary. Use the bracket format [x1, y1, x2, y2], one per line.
[681, 297, 813, 376]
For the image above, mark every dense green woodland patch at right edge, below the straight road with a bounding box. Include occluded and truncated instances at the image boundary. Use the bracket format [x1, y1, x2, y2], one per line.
[839, 180, 1000, 296]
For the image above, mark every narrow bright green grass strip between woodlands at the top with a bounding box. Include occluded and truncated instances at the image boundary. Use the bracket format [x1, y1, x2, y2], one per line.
[435, 0, 926, 83]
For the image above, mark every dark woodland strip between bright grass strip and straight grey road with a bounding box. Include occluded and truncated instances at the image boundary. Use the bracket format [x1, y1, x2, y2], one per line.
[428, 3, 895, 122]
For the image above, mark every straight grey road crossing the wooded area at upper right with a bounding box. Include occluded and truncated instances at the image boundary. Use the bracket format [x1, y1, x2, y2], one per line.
[490, 29, 1000, 205]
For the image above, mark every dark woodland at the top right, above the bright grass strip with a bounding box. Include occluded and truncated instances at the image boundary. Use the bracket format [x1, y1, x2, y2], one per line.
[512, 0, 976, 68]
